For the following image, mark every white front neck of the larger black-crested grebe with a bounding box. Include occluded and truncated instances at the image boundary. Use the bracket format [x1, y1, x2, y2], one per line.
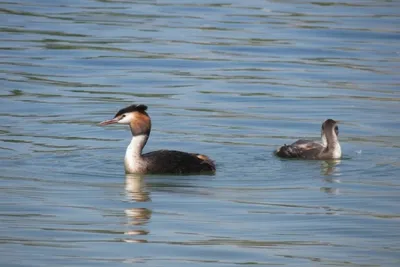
[125, 135, 149, 173]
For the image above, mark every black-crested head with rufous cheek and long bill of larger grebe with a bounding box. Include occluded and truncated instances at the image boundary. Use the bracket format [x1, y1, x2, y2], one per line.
[100, 104, 151, 136]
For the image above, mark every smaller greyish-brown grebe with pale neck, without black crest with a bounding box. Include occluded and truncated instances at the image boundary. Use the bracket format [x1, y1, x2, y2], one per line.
[275, 119, 342, 160]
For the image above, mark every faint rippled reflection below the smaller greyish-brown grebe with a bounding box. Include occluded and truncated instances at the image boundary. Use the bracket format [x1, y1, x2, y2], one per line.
[320, 160, 341, 195]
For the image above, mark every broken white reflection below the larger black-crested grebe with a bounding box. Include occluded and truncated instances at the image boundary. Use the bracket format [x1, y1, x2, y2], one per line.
[124, 174, 152, 243]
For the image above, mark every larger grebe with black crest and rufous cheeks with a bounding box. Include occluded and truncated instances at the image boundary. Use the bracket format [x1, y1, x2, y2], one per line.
[100, 105, 216, 174]
